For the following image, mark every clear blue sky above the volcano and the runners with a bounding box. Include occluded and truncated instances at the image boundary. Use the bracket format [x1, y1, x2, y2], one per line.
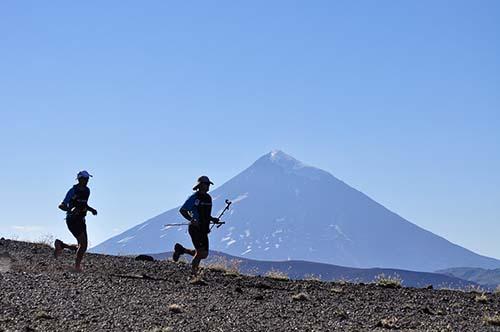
[0, 0, 500, 258]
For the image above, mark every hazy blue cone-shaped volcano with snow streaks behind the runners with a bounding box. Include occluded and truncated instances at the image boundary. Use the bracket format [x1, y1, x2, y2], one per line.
[91, 151, 500, 271]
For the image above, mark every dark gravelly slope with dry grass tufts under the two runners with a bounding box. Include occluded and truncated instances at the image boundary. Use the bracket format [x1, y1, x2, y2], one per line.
[0, 239, 500, 331]
